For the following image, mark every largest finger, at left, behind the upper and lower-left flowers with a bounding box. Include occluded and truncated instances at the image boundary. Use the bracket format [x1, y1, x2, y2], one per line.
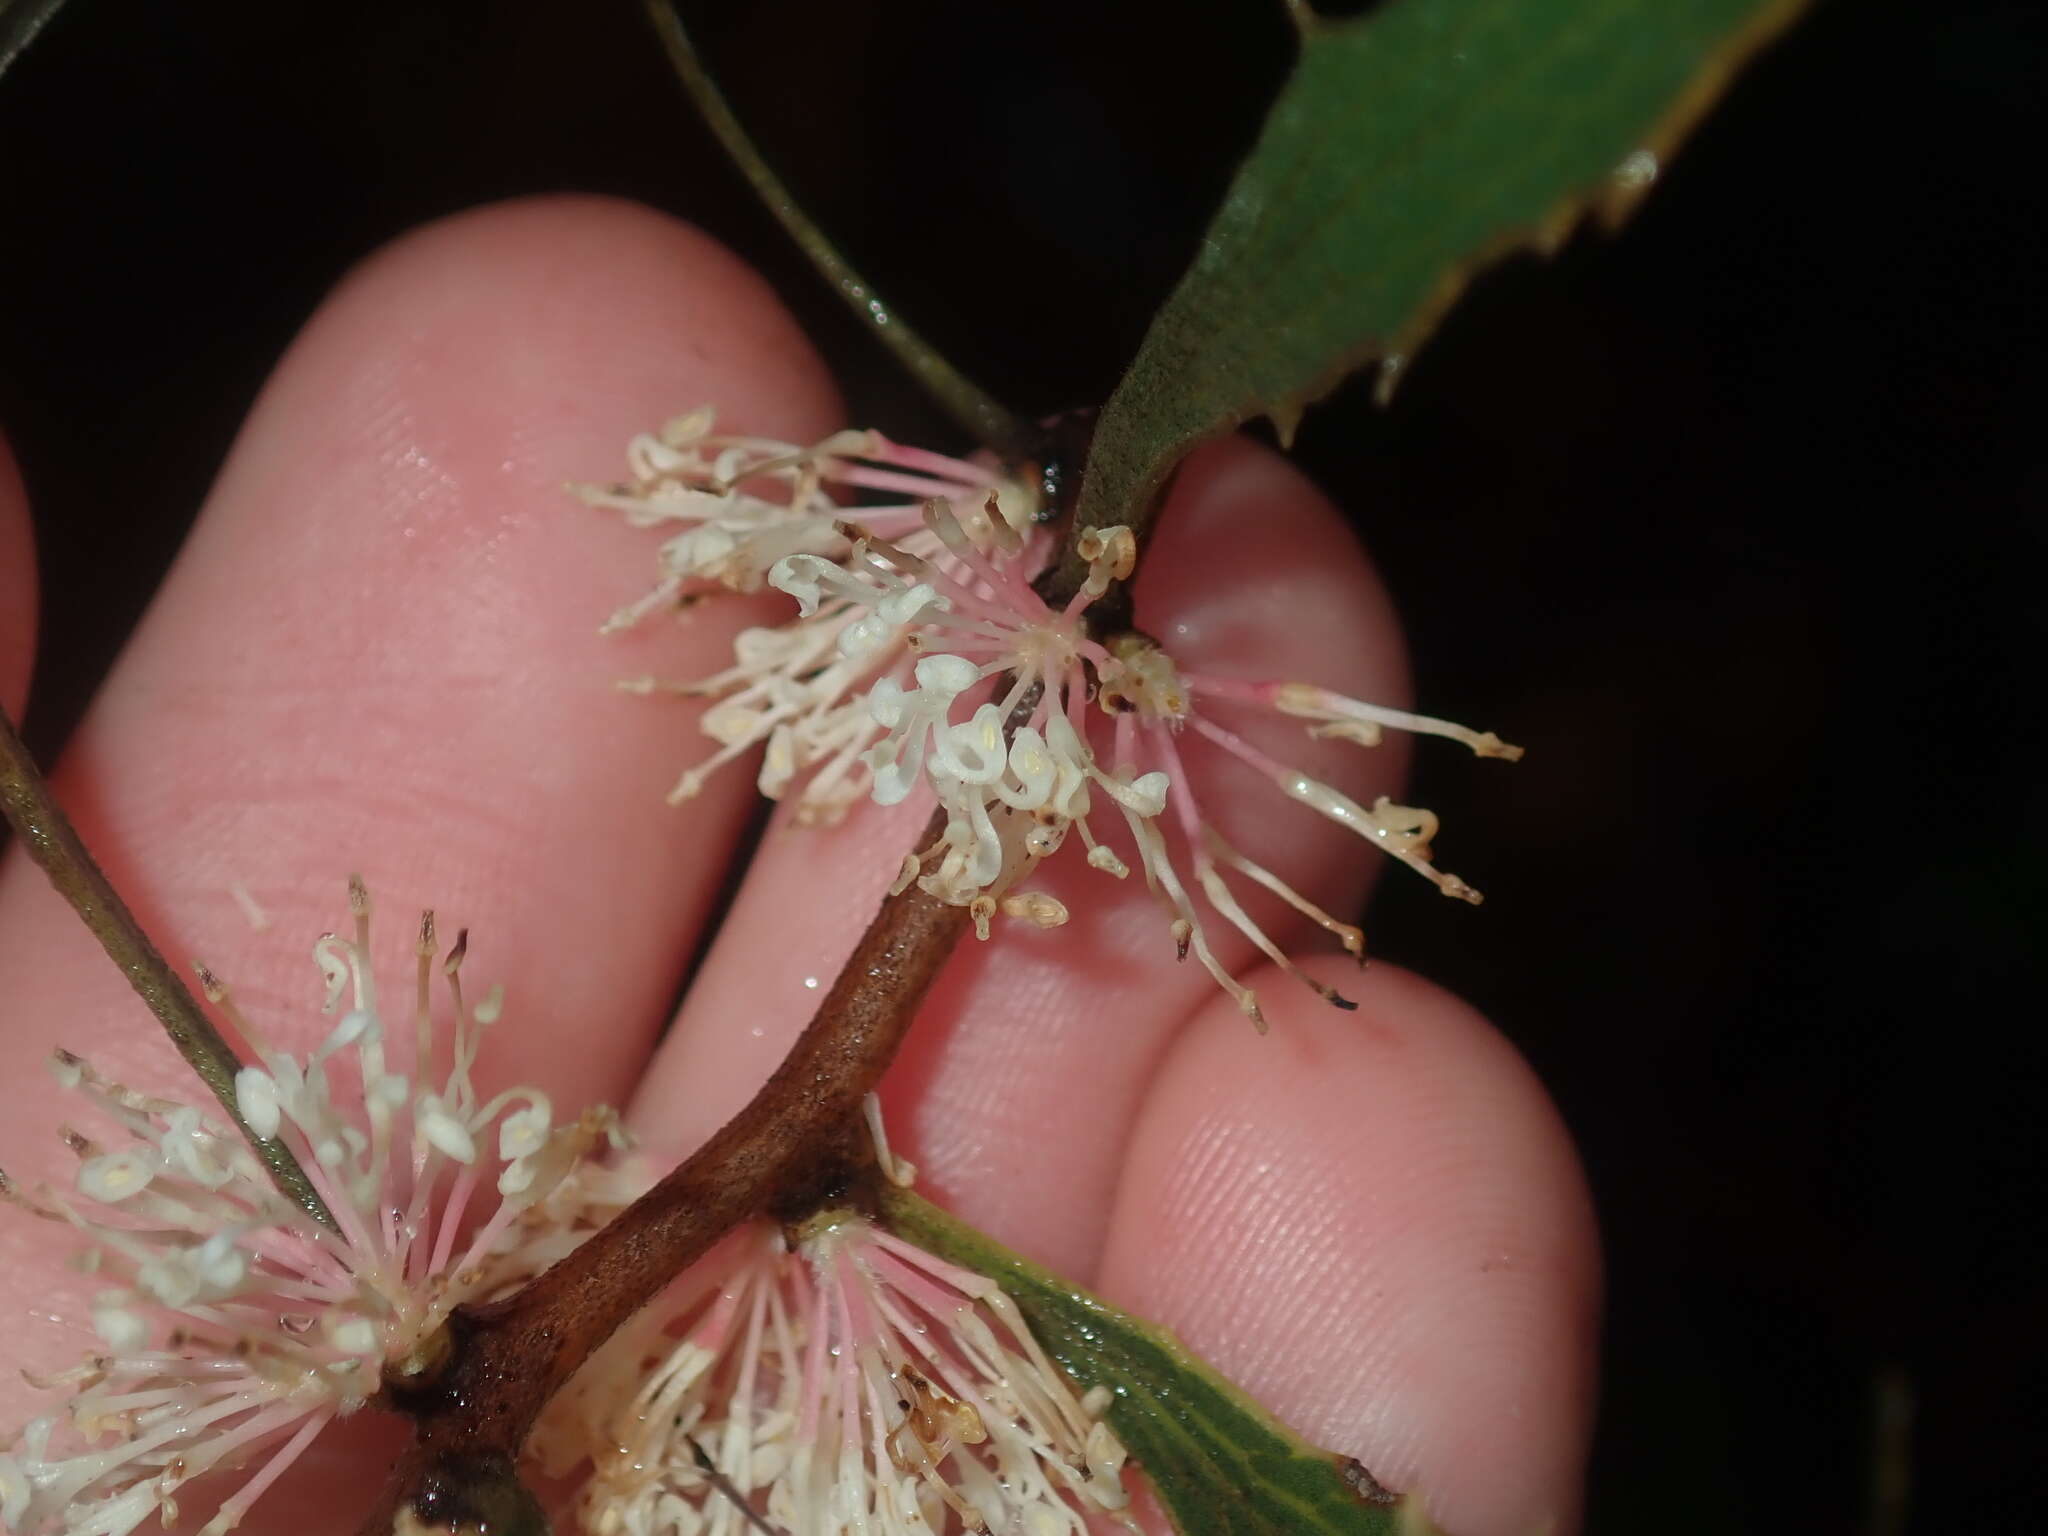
[0, 201, 836, 1466]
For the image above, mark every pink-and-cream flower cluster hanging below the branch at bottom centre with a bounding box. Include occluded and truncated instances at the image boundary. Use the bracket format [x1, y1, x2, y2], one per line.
[539, 1210, 1135, 1536]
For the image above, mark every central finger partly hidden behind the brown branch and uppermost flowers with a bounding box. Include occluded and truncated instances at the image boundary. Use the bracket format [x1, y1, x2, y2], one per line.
[639, 442, 1441, 1274]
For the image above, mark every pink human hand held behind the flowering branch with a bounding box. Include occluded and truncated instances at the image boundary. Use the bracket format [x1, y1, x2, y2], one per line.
[0, 201, 1597, 1536]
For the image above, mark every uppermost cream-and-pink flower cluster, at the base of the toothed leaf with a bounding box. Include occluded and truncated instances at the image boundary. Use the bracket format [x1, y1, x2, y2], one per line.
[592, 412, 1522, 1026]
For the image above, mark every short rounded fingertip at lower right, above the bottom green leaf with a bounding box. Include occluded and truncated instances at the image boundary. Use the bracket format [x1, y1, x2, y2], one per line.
[1100, 963, 1599, 1536]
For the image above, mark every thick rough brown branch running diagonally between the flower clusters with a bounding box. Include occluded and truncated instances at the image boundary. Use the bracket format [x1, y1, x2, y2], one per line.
[362, 813, 969, 1532]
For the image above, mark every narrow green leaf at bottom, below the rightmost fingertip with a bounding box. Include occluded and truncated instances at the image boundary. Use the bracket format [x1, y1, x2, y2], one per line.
[881, 1188, 1430, 1536]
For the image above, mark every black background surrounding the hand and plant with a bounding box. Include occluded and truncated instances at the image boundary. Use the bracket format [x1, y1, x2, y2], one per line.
[0, 0, 2048, 1536]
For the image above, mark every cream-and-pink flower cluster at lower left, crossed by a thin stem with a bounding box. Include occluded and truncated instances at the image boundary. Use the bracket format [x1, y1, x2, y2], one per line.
[0, 881, 625, 1536]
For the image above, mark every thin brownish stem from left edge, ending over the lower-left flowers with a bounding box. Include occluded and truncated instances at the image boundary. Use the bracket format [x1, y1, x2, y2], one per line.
[0, 711, 334, 1229]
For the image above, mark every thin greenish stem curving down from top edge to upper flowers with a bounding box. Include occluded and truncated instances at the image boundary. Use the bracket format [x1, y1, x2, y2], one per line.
[647, 0, 1038, 461]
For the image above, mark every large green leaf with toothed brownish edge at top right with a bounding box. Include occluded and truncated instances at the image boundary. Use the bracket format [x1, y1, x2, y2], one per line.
[1077, 0, 1802, 526]
